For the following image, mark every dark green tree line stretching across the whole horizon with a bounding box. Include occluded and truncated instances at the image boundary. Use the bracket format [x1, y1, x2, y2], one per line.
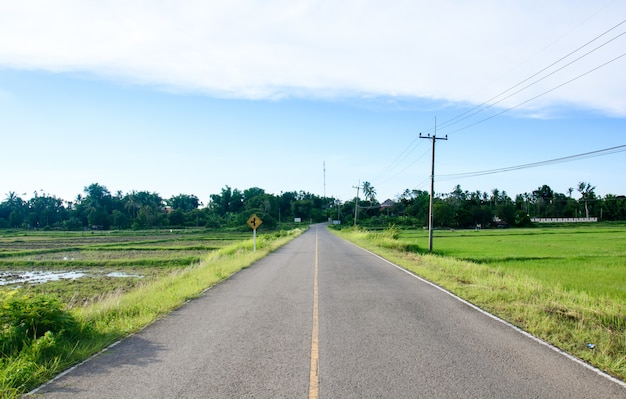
[0, 182, 626, 230]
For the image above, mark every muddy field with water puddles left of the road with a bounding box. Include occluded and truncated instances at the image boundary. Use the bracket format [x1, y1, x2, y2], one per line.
[0, 230, 249, 306]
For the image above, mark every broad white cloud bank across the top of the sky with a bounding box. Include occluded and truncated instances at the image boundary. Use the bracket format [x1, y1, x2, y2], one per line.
[0, 0, 626, 116]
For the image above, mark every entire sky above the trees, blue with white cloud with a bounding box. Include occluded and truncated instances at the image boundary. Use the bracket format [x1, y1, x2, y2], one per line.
[0, 0, 626, 203]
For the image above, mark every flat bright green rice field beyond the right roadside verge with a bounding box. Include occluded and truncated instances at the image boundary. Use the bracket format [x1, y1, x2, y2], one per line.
[400, 225, 626, 304]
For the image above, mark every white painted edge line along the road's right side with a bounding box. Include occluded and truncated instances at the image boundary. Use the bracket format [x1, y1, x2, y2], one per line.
[342, 238, 626, 388]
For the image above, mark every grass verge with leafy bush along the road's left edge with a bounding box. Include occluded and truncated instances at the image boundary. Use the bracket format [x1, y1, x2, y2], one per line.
[0, 229, 302, 399]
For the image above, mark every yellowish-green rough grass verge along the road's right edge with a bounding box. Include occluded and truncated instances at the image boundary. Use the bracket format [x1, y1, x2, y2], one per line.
[336, 229, 626, 381]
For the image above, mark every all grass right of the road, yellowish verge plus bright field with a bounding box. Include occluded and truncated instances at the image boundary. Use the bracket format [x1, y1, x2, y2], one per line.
[339, 225, 626, 380]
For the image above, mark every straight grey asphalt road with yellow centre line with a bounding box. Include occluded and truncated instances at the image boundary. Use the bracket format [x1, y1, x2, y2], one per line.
[32, 225, 626, 399]
